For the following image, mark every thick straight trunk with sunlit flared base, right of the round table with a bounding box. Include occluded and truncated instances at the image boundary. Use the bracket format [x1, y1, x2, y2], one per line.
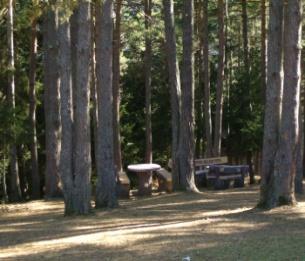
[179, 0, 197, 191]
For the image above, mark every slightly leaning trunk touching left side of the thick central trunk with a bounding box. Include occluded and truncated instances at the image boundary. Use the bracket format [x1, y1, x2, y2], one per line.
[163, 0, 181, 189]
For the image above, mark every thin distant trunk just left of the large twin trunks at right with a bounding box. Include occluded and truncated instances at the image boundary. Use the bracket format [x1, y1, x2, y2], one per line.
[261, 0, 267, 100]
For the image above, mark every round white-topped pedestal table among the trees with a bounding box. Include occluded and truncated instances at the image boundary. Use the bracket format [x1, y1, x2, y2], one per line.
[127, 163, 161, 196]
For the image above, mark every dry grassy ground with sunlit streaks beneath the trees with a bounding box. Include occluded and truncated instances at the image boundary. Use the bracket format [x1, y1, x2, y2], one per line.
[0, 186, 305, 261]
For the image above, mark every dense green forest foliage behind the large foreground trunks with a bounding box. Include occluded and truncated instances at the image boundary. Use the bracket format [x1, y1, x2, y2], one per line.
[0, 0, 303, 210]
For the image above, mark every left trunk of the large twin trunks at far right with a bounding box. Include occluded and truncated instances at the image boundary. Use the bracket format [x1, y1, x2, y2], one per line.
[259, 0, 283, 207]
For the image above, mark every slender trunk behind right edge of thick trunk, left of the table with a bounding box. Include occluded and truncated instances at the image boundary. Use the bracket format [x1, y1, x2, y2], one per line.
[113, 0, 123, 173]
